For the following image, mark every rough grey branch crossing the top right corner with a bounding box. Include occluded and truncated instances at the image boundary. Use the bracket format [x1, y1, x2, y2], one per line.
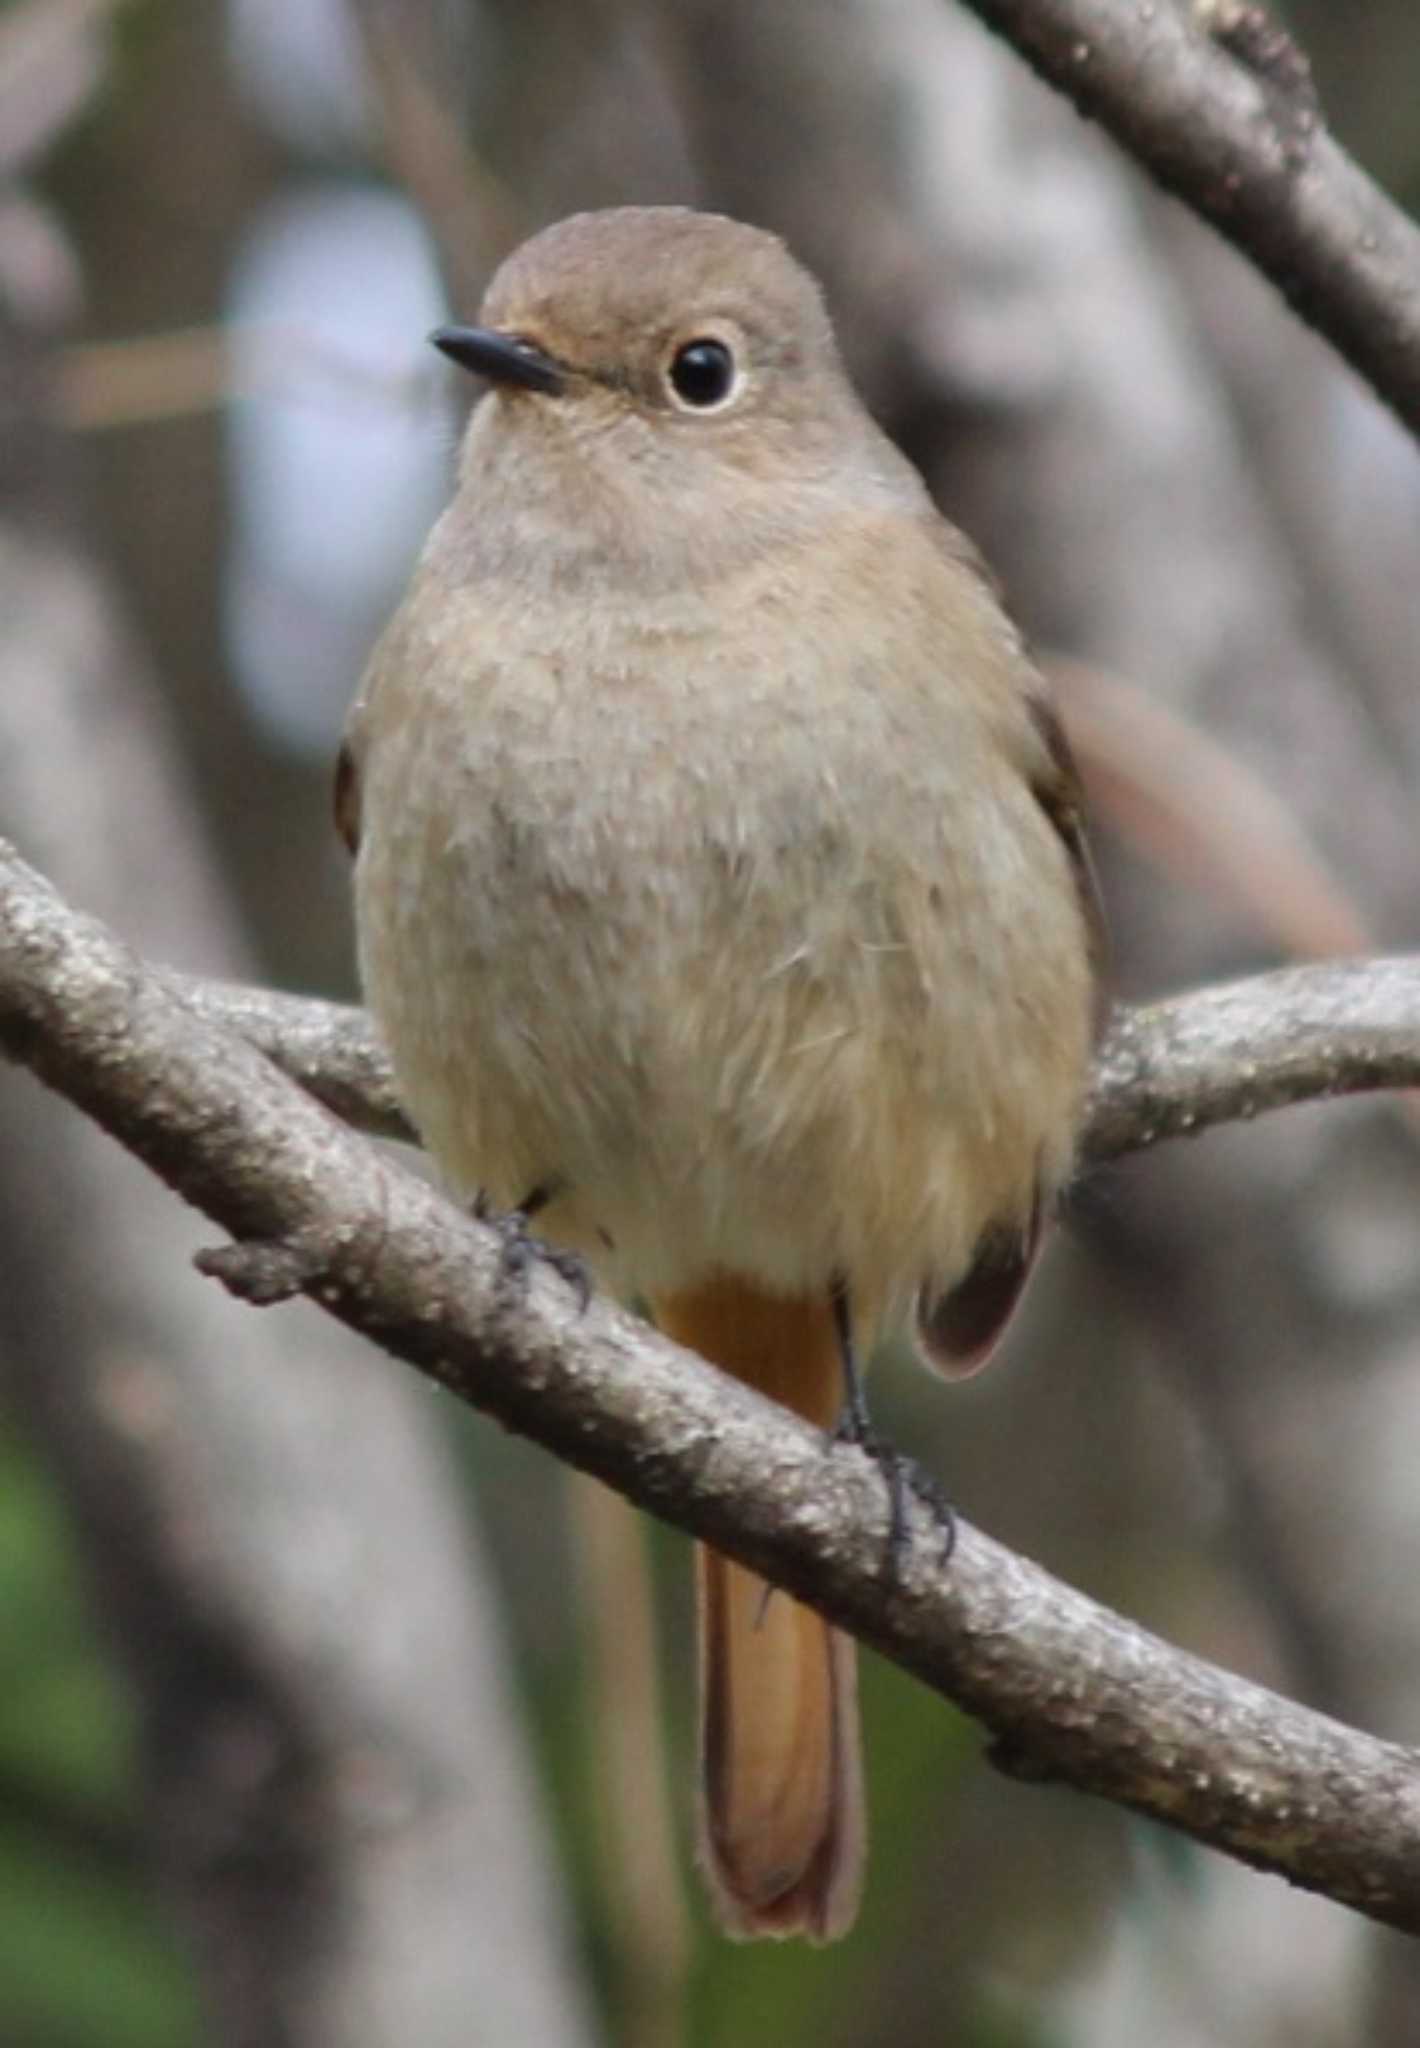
[946, 0, 1420, 432]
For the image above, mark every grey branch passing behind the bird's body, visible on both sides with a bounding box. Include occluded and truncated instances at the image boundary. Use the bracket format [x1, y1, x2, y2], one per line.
[170, 958, 1420, 1165]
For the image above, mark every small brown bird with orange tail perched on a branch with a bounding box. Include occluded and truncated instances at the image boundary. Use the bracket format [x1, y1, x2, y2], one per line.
[338, 207, 1094, 1939]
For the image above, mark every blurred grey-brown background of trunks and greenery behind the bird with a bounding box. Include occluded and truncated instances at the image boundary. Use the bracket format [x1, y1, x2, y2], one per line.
[0, 0, 1420, 2048]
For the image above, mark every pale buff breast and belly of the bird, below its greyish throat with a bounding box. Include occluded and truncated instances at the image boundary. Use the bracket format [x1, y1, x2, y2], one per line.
[357, 577, 1088, 1292]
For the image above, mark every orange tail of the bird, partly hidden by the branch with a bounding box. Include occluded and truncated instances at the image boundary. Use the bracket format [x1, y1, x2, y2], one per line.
[656, 1278, 865, 1942]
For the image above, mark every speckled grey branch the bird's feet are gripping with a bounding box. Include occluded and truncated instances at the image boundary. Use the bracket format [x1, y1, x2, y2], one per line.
[0, 842, 1420, 1931]
